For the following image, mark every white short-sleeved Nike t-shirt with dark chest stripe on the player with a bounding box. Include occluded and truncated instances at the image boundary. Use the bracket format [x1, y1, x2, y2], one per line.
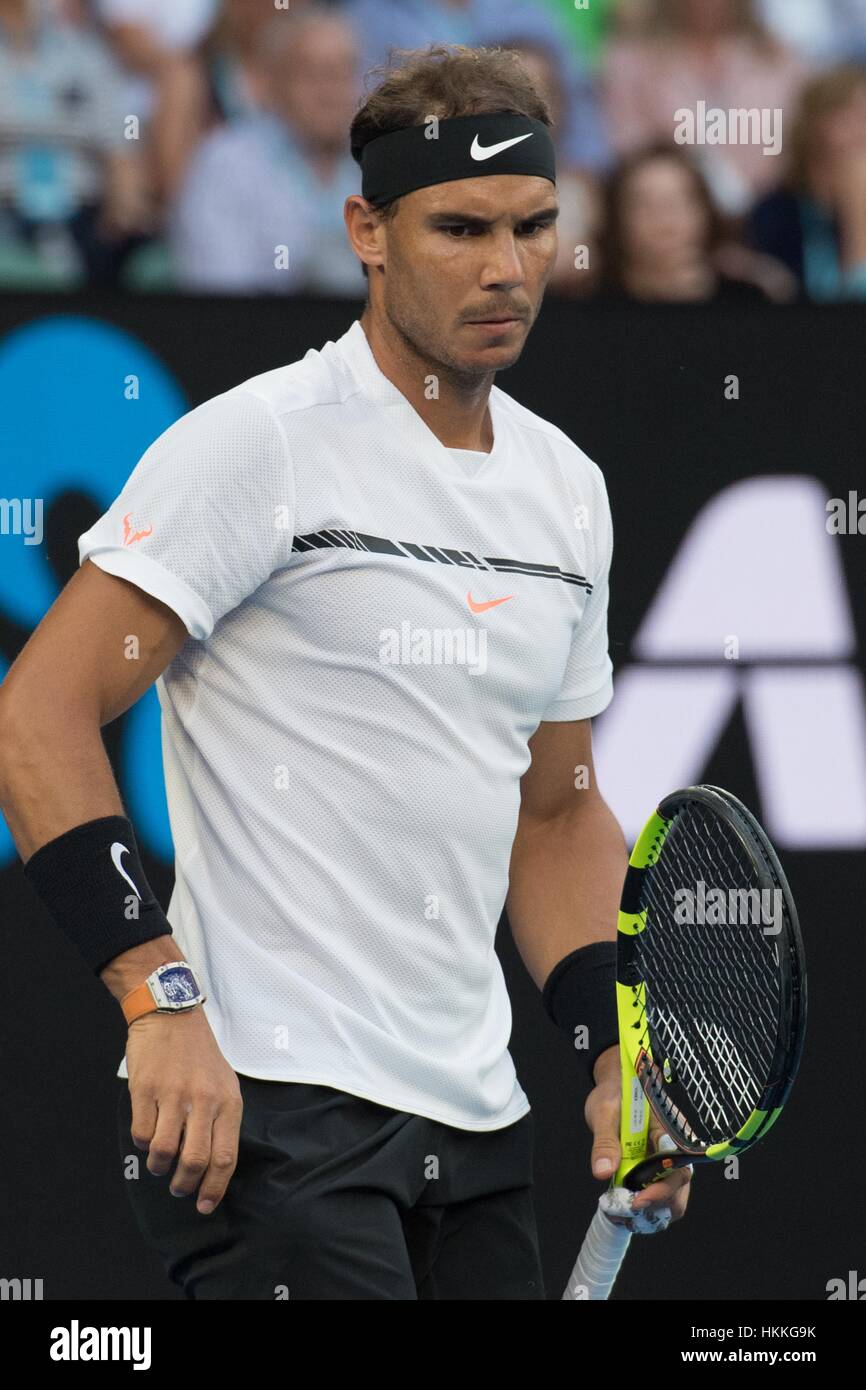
[79, 321, 612, 1130]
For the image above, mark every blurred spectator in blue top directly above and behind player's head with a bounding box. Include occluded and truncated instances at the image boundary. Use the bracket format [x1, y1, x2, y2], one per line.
[343, 0, 610, 171]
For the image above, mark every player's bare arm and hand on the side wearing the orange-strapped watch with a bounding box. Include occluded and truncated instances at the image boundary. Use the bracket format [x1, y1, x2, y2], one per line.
[0, 560, 240, 1209]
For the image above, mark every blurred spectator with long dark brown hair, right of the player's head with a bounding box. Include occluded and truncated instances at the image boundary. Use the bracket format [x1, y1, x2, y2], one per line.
[601, 145, 766, 303]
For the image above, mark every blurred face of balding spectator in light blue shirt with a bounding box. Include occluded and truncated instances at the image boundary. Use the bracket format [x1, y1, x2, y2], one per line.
[270, 19, 357, 149]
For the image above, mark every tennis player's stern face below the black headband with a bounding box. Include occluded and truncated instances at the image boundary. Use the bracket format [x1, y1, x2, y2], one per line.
[361, 174, 557, 377]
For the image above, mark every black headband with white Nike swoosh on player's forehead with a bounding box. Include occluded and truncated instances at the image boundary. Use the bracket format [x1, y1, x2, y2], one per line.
[361, 111, 556, 206]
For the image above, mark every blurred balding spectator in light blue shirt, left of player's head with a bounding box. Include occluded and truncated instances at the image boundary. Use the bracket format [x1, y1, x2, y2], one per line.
[171, 4, 364, 297]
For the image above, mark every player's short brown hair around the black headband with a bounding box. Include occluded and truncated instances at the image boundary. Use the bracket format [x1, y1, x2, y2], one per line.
[349, 43, 553, 275]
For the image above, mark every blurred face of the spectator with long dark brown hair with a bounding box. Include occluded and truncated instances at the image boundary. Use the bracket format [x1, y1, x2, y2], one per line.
[620, 158, 708, 270]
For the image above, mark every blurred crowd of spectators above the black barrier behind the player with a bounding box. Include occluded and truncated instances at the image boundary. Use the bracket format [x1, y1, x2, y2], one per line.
[0, 0, 866, 302]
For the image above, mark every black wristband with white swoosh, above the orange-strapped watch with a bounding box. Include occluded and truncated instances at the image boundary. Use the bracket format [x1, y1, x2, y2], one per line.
[24, 816, 171, 974]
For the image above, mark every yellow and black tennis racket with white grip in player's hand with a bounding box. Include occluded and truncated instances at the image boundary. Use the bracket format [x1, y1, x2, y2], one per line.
[563, 785, 806, 1300]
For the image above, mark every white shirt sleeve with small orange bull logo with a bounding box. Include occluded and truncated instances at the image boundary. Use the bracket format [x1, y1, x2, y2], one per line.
[78, 388, 295, 639]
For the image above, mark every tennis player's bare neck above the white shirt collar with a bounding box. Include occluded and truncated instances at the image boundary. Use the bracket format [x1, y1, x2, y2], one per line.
[360, 304, 495, 453]
